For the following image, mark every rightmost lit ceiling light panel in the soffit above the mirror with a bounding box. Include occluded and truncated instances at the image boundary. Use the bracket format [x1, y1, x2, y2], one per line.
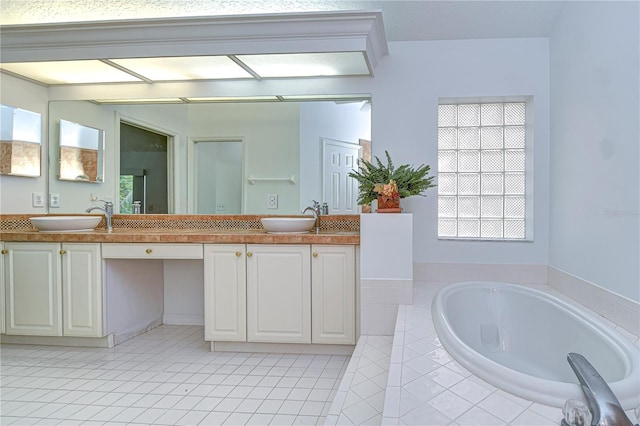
[236, 52, 371, 78]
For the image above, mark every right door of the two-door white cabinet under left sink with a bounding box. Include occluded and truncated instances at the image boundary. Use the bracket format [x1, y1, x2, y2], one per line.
[60, 243, 104, 337]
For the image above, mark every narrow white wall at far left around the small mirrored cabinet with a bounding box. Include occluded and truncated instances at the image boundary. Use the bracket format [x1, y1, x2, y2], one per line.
[0, 74, 49, 214]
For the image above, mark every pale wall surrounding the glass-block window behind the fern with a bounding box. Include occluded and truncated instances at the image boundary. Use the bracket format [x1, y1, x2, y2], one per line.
[371, 38, 549, 264]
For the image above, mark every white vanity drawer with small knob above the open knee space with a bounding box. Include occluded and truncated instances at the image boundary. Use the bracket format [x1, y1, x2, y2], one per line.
[102, 243, 203, 259]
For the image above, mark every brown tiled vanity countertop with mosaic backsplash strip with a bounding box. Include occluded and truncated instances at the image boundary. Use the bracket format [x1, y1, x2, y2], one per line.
[0, 214, 360, 245]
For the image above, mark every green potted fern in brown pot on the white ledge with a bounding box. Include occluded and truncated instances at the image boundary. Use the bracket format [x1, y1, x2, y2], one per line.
[349, 151, 435, 213]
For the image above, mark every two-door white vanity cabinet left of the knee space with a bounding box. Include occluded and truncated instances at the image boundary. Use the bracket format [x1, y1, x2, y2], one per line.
[3, 243, 103, 337]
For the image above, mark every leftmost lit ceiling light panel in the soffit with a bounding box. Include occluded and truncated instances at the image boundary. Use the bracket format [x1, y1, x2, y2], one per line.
[0, 60, 141, 84]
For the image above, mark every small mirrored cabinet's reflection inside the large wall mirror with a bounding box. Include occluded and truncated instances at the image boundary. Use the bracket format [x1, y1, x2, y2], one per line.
[58, 120, 104, 182]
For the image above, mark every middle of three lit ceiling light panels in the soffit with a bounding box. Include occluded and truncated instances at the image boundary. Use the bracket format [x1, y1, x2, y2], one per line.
[109, 56, 253, 81]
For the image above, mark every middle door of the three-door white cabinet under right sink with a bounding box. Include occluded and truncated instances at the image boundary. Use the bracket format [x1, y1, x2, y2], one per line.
[247, 244, 311, 343]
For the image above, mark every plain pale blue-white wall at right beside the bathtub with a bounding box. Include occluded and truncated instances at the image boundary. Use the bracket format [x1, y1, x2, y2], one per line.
[549, 2, 640, 301]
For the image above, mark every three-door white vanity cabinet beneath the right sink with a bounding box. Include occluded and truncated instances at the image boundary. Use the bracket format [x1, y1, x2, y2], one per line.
[204, 244, 356, 345]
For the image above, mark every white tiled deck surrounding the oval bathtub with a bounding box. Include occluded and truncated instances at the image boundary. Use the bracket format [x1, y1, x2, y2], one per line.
[382, 281, 640, 426]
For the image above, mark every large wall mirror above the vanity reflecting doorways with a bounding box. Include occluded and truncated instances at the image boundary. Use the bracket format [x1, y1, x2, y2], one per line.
[49, 96, 371, 214]
